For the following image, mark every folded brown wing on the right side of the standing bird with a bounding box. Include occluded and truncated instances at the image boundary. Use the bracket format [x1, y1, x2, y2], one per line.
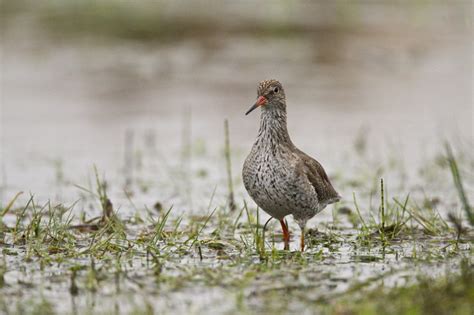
[296, 149, 341, 204]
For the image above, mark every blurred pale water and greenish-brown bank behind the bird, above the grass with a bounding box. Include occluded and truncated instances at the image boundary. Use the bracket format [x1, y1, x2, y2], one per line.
[0, 0, 473, 215]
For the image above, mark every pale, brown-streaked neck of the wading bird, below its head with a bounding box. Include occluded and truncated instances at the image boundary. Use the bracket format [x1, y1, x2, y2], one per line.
[257, 109, 292, 145]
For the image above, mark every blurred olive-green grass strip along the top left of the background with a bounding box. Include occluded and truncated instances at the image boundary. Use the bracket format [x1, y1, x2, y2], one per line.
[2, 0, 305, 43]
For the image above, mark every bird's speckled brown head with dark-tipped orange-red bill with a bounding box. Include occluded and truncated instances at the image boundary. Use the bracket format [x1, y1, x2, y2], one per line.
[245, 80, 286, 115]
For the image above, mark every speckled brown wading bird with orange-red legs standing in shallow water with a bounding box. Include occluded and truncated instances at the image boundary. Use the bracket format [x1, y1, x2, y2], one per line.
[242, 79, 341, 252]
